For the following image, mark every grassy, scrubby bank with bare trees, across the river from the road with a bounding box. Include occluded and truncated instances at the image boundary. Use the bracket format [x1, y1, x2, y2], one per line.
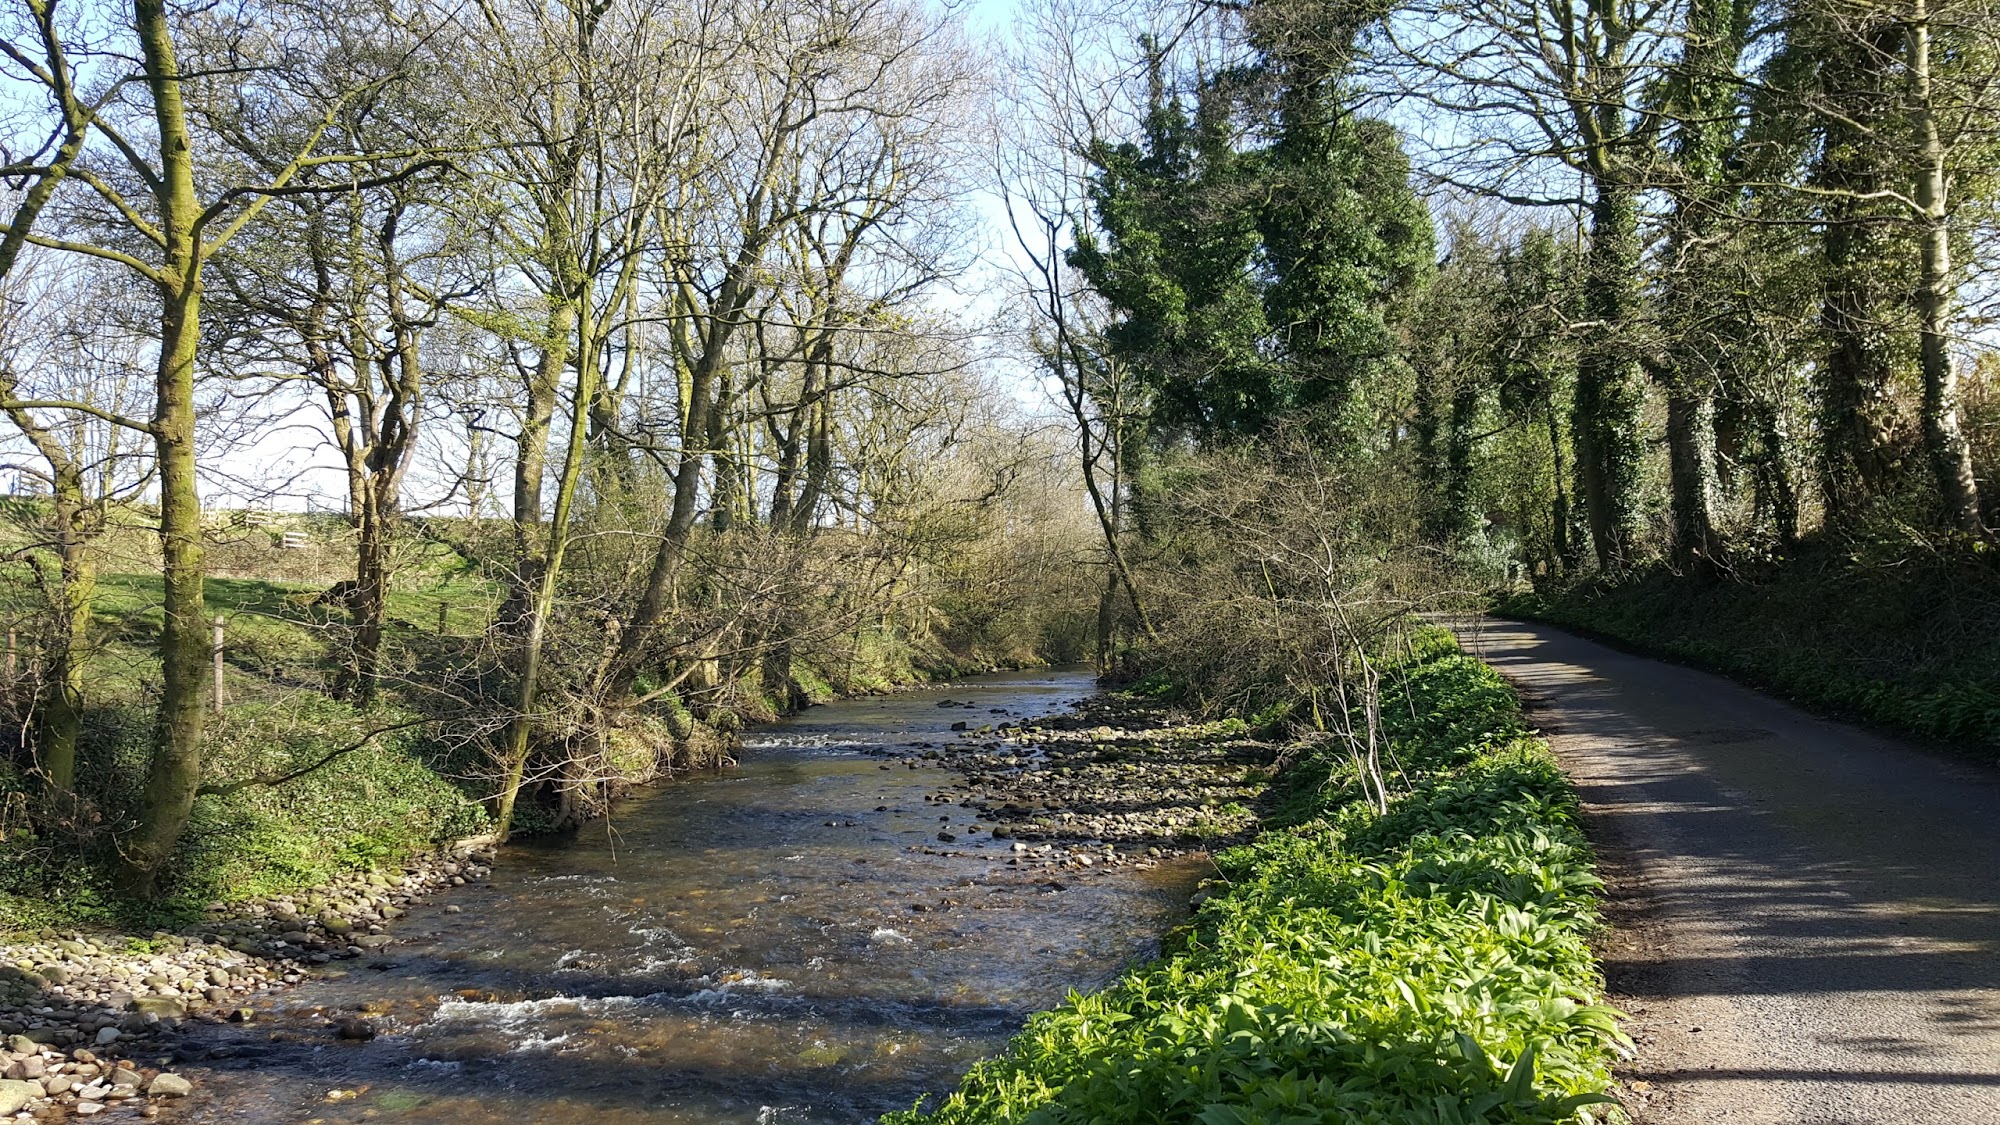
[0, 552, 1080, 941]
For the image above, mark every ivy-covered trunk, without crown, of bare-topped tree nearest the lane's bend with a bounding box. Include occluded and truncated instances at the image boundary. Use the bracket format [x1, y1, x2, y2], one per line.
[1572, 183, 1644, 573]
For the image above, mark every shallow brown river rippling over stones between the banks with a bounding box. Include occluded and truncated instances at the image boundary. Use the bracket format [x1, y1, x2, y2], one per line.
[176, 673, 1200, 1125]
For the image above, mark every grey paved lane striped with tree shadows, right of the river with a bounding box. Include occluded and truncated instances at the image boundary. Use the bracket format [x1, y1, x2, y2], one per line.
[1460, 621, 2000, 1125]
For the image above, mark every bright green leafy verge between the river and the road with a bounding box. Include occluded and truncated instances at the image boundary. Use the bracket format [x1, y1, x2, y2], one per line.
[884, 631, 1622, 1125]
